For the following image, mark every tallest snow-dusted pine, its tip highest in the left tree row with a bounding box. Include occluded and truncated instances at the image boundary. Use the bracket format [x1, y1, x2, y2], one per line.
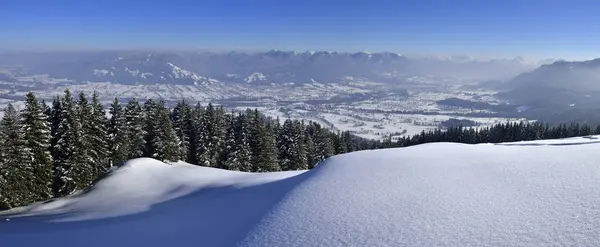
[52, 89, 93, 197]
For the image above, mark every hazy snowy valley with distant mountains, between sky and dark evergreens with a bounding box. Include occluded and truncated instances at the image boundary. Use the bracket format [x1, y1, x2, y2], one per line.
[0, 50, 576, 139]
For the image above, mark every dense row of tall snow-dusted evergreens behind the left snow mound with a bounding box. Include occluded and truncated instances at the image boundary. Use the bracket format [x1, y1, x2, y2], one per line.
[0, 90, 366, 209]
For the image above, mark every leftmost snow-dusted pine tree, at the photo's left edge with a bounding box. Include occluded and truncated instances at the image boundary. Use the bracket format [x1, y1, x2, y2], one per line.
[0, 104, 37, 208]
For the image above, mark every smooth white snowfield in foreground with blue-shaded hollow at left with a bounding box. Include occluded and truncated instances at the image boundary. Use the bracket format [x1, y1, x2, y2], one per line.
[0, 137, 600, 247]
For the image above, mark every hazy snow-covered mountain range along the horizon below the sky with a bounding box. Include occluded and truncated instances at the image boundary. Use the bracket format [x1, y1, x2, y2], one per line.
[0, 50, 536, 85]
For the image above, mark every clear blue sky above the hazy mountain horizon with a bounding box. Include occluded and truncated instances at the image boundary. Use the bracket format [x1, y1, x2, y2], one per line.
[0, 0, 600, 59]
